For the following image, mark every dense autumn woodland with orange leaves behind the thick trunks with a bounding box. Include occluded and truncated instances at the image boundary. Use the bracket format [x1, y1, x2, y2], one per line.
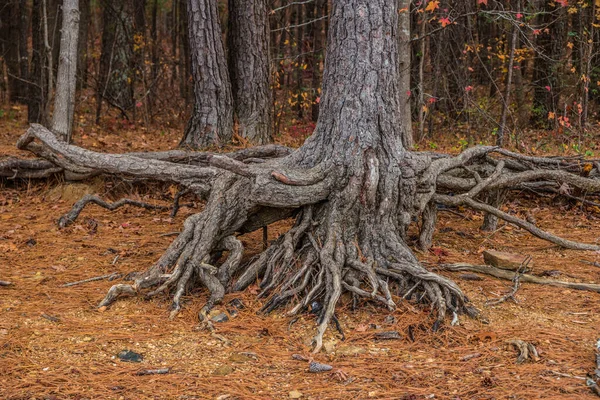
[0, 0, 600, 151]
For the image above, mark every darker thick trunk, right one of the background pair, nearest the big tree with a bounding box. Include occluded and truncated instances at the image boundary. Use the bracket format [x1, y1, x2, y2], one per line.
[227, 0, 273, 144]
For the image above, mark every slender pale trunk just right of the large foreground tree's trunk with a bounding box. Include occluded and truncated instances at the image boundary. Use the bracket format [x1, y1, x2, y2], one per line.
[398, 0, 413, 149]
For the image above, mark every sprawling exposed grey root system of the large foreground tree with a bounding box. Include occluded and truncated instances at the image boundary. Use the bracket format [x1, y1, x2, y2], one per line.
[19, 125, 600, 351]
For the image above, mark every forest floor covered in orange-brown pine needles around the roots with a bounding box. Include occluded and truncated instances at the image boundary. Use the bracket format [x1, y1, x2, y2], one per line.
[0, 110, 600, 399]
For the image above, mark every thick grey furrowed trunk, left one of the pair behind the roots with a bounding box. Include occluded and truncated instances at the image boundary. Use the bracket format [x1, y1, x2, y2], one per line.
[180, 0, 233, 148]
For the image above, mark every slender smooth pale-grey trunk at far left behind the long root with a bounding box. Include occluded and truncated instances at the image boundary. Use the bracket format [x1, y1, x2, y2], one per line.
[52, 0, 79, 143]
